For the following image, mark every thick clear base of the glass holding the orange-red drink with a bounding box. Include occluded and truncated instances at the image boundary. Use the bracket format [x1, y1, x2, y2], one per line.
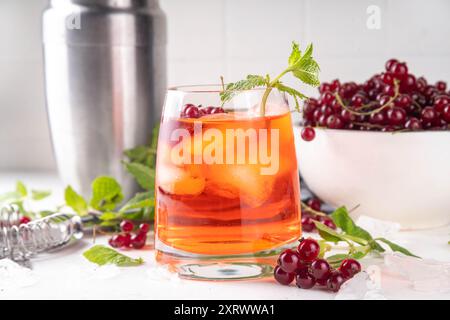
[156, 242, 295, 281]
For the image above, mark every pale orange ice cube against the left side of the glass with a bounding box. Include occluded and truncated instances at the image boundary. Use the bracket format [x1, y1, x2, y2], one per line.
[157, 164, 205, 195]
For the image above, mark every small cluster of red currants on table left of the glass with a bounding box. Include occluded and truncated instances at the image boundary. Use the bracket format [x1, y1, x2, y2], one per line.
[108, 220, 150, 249]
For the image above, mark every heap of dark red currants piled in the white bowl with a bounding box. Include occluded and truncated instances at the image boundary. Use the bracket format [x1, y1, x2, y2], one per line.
[302, 59, 450, 141]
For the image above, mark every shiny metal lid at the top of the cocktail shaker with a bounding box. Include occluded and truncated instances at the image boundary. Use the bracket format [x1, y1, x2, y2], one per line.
[42, 0, 166, 46]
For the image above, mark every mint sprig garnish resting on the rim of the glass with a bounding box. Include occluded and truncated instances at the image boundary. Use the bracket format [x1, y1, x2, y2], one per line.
[220, 42, 320, 116]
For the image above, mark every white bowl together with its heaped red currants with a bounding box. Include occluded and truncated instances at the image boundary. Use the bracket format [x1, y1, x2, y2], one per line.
[296, 59, 450, 229]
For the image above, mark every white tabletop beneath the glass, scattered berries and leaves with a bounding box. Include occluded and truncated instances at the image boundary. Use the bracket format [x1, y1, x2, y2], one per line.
[0, 172, 450, 300]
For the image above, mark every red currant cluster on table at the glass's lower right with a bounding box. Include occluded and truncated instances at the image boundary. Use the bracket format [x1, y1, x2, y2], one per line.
[274, 238, 361, 292]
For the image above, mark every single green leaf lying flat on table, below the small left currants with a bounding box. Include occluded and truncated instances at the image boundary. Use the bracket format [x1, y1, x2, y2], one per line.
[83, 245, 144, 267]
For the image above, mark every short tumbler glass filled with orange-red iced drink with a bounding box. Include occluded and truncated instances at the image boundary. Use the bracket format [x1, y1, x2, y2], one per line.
[155, 85, 301, 280]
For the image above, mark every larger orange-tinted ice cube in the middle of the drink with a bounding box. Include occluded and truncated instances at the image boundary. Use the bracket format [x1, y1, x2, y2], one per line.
[205, 164, 275, 208]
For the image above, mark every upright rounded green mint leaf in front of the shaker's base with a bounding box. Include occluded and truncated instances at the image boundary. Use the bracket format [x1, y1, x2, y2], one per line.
[91, 176, 123, 211]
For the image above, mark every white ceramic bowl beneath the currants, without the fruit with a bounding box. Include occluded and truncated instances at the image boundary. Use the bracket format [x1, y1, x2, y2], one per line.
[295, 127, 450, 229]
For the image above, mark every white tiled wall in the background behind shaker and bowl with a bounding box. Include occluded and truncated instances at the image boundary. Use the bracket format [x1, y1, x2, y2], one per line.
[0, 0, 450, 169]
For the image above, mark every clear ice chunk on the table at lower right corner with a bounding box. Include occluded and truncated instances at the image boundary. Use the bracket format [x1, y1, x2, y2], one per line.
[384, 253, 450, 293]
